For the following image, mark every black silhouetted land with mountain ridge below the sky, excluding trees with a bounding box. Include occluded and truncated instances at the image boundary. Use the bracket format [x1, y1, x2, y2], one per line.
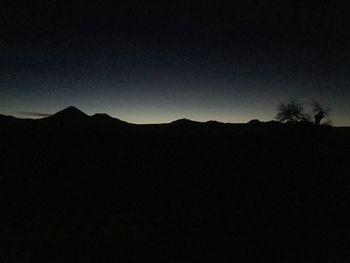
[0, 107, 350, 262]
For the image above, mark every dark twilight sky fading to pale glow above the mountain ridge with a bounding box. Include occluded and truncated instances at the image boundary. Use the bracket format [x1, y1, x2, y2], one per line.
[0, 0, 350, 126]
